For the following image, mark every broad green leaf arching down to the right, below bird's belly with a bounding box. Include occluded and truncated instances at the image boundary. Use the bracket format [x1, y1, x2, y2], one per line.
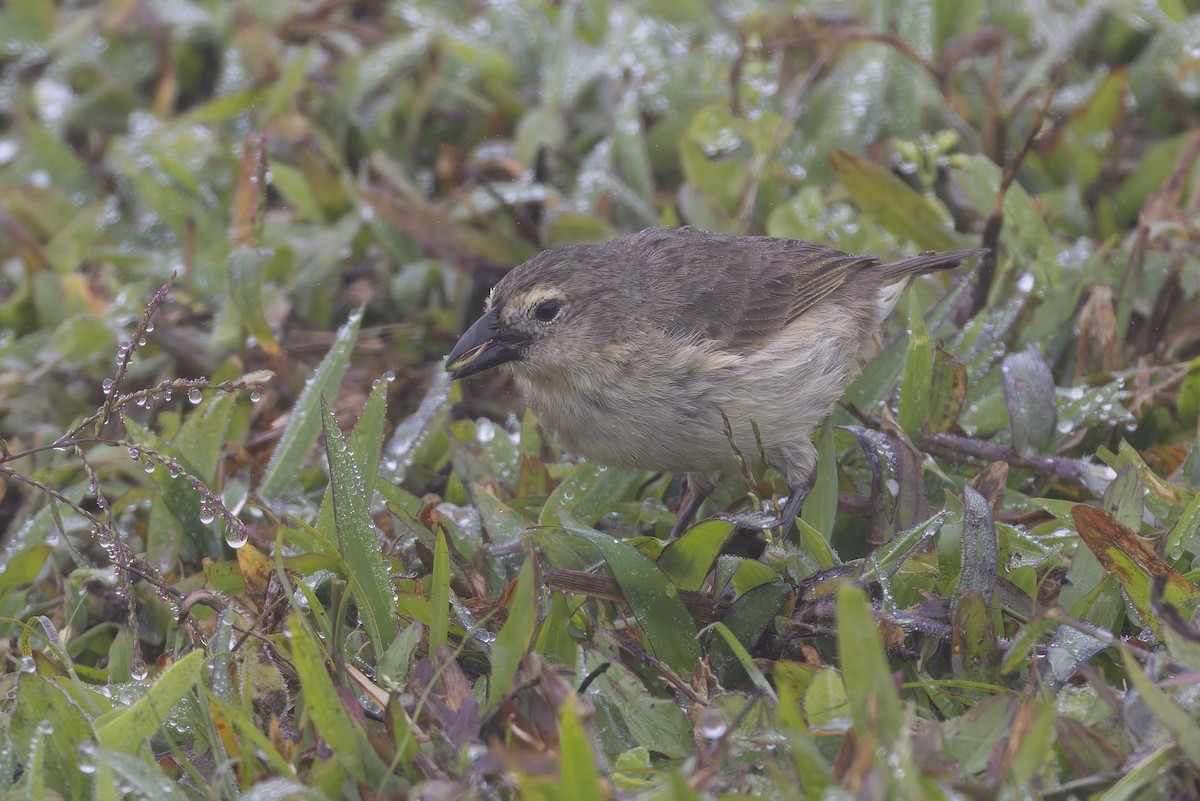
[563, 525, 700, 675]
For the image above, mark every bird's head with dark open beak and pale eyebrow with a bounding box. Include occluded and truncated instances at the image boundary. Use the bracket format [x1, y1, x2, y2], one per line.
[446, 246, 616, 379]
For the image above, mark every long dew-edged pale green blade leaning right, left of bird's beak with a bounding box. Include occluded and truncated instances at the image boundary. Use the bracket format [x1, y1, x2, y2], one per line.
[258, 309, 362, 500]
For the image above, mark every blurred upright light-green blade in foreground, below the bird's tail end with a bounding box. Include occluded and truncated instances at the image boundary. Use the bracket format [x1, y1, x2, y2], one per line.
[838, 583, 904, 746]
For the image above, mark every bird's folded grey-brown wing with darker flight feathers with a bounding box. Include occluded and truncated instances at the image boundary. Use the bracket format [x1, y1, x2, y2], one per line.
[653, 231, 876, 353]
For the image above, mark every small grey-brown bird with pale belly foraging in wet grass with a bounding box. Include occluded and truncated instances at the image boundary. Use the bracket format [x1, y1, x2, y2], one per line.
[445, 227, 984, 538]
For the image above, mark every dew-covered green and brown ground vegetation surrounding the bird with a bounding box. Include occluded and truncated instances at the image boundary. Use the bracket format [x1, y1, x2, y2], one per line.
[0, 0, 1200, 801]
